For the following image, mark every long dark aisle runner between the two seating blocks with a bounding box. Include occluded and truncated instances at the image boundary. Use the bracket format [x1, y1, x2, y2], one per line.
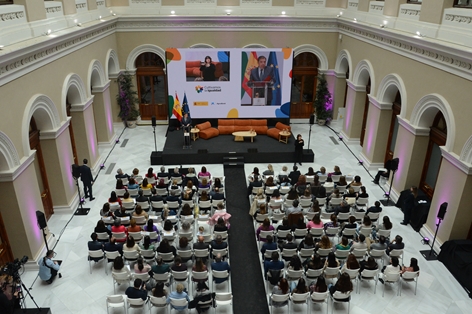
[225, 168, 269, 314]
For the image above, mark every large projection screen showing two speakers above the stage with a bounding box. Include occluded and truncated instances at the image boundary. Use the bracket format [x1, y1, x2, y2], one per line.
[166, 48, 293, 119]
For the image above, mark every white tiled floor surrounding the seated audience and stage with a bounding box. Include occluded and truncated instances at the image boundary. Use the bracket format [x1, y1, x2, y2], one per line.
[18, 121, 472, 314]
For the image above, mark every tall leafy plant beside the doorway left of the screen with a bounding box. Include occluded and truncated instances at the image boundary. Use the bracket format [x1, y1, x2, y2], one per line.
[116, 72, 139, 128]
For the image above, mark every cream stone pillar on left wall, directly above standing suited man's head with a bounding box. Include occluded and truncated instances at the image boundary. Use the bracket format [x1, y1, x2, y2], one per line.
[70, 96, 99, 168]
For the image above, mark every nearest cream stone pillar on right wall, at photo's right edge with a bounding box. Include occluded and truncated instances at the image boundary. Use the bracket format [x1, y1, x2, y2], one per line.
[422, 151, 472, 252]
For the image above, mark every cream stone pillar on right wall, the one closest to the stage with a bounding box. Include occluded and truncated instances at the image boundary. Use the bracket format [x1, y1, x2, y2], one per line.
[342, 80, 366, 143]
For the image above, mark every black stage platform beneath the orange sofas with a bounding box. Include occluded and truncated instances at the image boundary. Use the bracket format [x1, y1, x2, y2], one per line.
[155, 131, 314, 165]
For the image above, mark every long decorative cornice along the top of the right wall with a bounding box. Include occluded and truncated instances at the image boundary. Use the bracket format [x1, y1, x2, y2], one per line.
[339, 21, 472, 80]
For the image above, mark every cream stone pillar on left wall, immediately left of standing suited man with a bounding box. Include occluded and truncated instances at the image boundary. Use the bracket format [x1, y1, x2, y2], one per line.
[40, 117, 77, 210]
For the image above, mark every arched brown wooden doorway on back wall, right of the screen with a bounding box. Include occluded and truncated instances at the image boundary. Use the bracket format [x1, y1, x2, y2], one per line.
[290, 52, 319, 119]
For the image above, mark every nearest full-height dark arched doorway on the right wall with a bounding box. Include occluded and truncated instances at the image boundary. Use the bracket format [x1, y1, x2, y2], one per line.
[419, 111, 447, 199]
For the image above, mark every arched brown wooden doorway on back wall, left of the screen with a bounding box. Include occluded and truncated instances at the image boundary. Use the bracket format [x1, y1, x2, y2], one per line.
[136, 52, 168, 120]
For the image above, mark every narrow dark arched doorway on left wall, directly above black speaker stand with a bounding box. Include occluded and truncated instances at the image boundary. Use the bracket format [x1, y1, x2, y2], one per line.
[29, 117, 54, 219]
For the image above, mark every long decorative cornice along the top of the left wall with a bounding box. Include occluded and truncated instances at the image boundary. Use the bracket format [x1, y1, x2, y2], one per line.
[0, 20, 116, 86]
